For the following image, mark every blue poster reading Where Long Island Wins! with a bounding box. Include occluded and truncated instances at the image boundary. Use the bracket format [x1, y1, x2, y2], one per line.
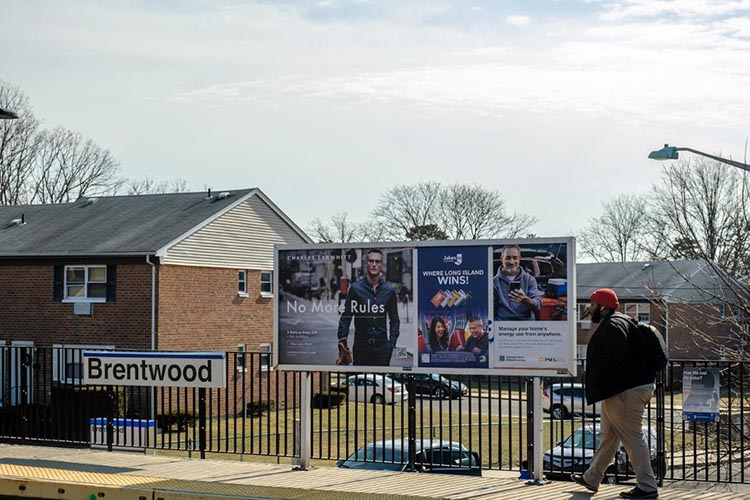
[417, 246, 490, 368]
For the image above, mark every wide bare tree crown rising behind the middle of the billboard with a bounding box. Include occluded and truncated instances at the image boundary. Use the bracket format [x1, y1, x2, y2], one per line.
[375, 182, 537, 239]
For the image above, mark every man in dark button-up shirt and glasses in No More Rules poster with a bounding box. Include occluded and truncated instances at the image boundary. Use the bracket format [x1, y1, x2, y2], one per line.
[338, 249, 401, 366]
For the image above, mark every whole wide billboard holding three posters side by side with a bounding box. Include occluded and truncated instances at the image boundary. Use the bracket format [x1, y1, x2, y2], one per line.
[274, 238, 576, 376]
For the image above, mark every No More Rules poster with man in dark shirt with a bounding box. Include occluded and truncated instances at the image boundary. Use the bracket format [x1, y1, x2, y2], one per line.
[277, 247, 416, 369]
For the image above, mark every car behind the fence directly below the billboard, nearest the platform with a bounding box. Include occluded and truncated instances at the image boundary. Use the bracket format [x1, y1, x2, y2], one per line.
[336, 438, 482, 476]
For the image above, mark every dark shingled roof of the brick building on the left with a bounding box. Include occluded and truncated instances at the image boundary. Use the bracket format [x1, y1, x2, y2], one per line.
[0, 188, 280, 258]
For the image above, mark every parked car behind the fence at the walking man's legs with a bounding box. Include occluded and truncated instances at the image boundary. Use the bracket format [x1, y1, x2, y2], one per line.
[542, 425, 657, 475]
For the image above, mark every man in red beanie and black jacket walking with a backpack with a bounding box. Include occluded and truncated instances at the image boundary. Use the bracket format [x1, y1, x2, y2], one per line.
[571, 288, 659, 498]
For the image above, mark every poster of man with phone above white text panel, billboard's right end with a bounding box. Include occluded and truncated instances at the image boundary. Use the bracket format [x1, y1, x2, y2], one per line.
[492, 241, 575, 370]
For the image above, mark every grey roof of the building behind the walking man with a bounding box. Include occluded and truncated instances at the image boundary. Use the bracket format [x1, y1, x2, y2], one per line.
[576, 259, 746, 303]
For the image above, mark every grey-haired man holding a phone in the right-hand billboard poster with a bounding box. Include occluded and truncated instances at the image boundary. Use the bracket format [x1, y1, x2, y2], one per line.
[492, 245, 542, 321]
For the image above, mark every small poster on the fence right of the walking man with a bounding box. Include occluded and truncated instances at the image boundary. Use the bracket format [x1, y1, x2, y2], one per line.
[682, 368, 719, 422]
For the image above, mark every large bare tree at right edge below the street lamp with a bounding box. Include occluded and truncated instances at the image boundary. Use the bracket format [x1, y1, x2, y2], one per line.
[649, 157, 750, 277]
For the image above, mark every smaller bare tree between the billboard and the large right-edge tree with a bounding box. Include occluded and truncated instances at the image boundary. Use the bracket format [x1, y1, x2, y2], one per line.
[578, 194, 653, 262]
